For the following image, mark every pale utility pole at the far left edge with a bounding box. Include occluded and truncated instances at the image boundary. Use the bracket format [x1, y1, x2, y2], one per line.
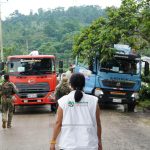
[0, 0, 4, 62]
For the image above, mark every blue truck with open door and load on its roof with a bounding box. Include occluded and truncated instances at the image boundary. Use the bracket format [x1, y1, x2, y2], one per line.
[75, 44, 149, 111]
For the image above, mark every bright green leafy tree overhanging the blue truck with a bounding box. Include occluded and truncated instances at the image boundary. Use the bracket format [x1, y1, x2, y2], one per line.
[74, 0, 150, 61]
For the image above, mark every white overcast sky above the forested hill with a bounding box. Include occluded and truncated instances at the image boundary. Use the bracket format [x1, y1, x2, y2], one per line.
[0, 0, 121, 19]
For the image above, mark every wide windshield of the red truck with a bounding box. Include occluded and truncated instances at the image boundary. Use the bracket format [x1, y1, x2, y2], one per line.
[8, 58, 55, 75]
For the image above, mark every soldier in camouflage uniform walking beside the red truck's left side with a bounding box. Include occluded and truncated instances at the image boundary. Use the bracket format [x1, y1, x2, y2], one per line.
[1, 75, 16, 128]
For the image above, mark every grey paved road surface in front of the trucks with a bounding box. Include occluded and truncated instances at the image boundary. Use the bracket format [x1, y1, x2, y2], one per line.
[0, 106, 150, 150]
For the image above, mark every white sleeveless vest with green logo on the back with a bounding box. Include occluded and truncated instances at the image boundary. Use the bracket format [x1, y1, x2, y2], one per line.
[58, 91, 98, 150]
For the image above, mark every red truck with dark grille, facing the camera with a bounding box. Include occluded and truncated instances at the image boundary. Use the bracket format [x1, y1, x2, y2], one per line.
[1, 55, 56, 111]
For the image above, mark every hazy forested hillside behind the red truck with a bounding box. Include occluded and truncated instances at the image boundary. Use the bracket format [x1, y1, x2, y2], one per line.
[3, 6, 105, 61]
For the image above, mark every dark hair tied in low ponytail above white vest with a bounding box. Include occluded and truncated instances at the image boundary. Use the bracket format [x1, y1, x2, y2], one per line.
[70, 73, 85, 102]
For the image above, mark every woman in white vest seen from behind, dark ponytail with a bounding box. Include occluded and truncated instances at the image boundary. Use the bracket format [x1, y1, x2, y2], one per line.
[50, 73, 102, 150]
